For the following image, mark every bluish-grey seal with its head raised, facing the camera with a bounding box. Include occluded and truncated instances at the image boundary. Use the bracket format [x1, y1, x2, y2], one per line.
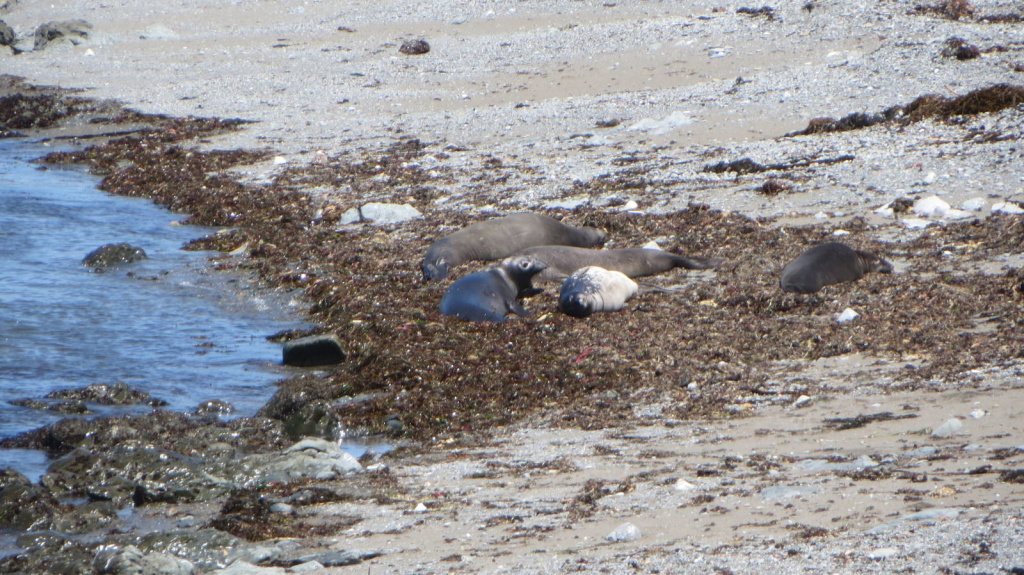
[441, 256, 545, 322]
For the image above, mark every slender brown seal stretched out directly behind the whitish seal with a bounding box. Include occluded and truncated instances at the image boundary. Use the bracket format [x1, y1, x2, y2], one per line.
[516, 246, 725, 279]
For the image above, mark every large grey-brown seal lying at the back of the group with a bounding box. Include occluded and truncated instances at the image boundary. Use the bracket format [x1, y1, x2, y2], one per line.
[422, 213, 607, 279]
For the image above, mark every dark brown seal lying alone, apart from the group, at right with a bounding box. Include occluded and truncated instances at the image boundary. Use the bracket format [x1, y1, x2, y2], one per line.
[779, 241, 893, 294]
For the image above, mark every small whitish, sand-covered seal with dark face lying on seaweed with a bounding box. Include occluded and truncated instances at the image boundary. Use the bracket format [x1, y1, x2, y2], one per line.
[558, 266, 639, 317]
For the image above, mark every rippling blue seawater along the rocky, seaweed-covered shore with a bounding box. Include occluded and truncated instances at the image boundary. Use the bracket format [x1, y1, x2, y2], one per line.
[0, 140, 303, 480]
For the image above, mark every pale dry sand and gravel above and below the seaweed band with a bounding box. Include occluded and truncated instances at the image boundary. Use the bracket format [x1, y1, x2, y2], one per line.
[0, 0, 1024, 574]
